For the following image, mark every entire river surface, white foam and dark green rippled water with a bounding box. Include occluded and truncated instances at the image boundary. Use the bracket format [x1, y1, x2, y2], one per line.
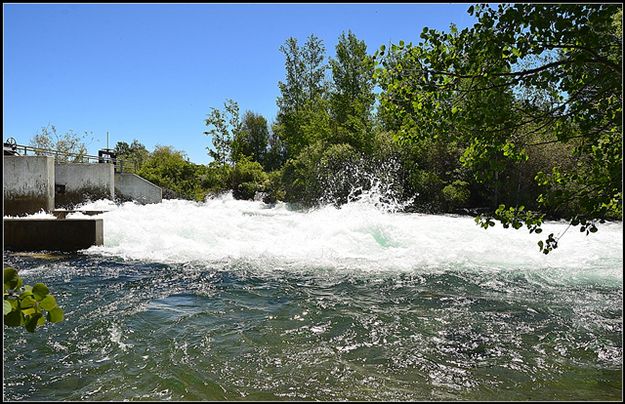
[4, 193, 623, 400]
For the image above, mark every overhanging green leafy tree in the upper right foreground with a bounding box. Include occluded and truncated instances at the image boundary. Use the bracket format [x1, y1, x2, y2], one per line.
[376, 4, 622, 253]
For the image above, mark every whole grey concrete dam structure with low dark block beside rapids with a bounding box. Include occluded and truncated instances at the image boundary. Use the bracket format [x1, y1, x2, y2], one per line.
[3, 154, 162, 251]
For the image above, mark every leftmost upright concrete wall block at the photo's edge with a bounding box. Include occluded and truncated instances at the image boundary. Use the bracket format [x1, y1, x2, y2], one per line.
[2, 156, 55, 216]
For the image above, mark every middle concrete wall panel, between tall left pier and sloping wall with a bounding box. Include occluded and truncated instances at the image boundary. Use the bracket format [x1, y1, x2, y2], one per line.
[54, 163, 115, 208]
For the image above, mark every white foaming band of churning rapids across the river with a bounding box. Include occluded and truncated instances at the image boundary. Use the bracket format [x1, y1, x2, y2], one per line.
[63, 194, 623, 281]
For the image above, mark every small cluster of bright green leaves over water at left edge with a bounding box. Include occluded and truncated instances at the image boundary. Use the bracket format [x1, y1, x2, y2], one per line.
[3, 267, 63, 332]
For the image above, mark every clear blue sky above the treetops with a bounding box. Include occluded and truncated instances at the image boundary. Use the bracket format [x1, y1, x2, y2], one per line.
[3, 3, 473, 163]
